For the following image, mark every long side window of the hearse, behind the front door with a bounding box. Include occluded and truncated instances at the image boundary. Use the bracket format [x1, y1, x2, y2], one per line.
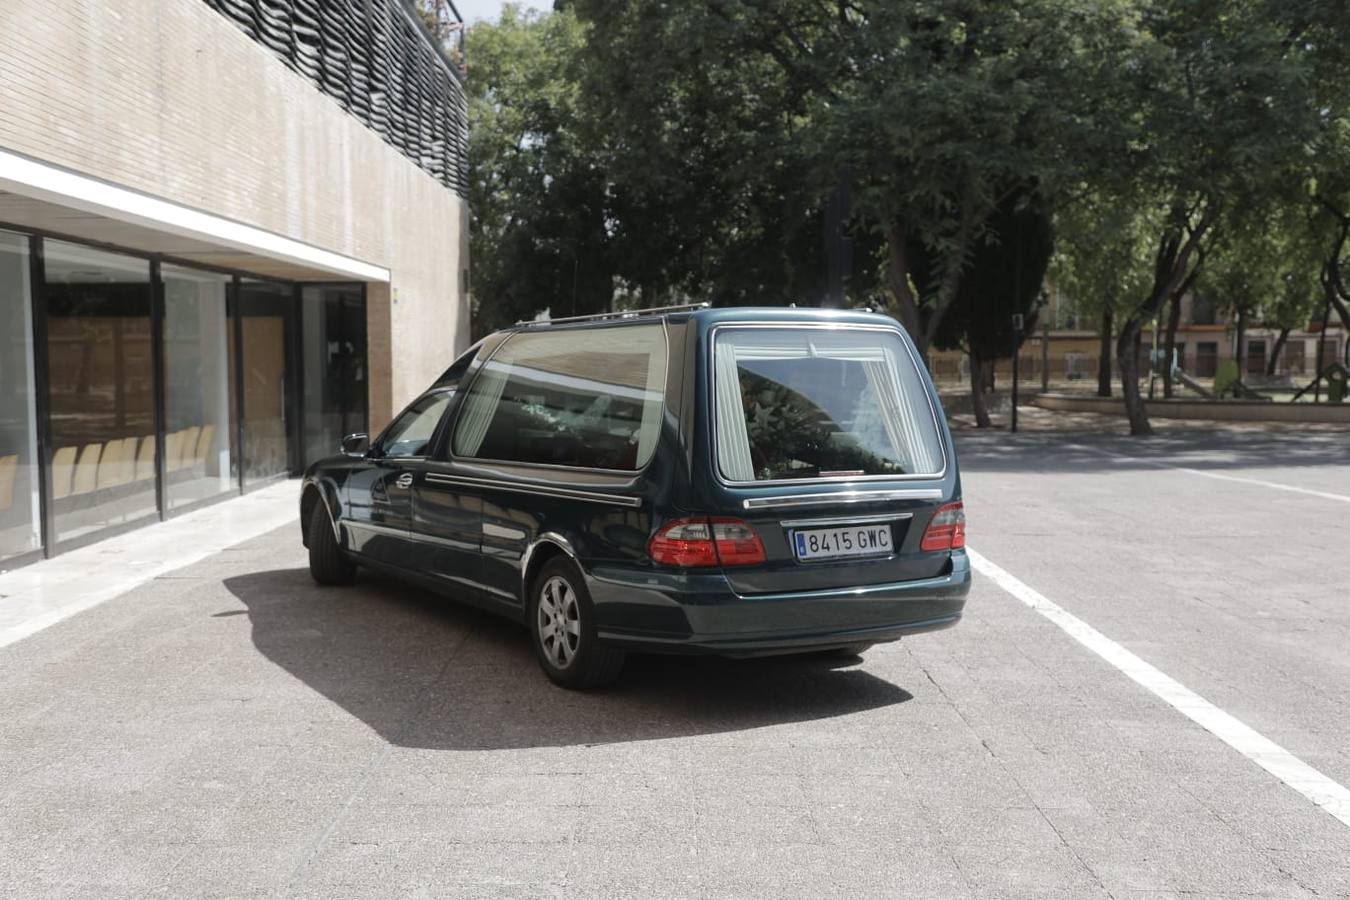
[452, 324, 667, 471]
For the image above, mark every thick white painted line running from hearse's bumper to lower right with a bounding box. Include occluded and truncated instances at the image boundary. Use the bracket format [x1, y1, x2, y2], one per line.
[967, 548, 1350, 826]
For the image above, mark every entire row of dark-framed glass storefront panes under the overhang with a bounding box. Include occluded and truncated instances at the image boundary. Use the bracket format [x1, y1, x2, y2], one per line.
[0, 231, 367, 569]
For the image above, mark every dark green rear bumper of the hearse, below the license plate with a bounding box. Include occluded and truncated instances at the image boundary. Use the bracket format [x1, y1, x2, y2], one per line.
[587, 552, 971, 656]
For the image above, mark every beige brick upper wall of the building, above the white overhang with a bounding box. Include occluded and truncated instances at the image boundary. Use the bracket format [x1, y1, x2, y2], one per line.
[0, 0, 468, 428]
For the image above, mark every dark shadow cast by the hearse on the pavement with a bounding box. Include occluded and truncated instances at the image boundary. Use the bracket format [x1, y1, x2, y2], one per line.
[224, 568, 911, 750]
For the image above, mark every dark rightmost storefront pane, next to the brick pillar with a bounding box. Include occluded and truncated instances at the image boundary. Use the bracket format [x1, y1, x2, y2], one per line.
[300, 285, 367, 463]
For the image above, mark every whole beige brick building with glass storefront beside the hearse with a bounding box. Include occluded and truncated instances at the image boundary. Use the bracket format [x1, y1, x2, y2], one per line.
[0, 0, 468, 568]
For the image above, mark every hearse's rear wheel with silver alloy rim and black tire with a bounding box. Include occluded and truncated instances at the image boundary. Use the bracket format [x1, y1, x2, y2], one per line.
[528, 556, 624, 691]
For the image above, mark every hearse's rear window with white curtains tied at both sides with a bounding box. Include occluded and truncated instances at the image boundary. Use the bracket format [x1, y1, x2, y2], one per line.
[713, 327, 942, 482]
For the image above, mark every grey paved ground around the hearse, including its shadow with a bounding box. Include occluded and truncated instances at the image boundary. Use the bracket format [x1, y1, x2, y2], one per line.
[0, 433, 1350, 899]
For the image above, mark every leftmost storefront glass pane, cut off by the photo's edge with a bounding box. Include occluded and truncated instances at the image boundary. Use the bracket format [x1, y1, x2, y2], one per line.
[0, 231, 42, 568]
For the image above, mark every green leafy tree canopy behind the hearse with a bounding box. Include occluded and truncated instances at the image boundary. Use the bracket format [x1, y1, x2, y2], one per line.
[468, 0, 1350, 396]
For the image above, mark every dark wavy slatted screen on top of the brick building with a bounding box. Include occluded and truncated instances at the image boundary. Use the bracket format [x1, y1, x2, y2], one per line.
[205, 0, 468, 197]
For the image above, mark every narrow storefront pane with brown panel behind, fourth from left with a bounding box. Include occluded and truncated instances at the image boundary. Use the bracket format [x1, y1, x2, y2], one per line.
[236, 279, 296, 484]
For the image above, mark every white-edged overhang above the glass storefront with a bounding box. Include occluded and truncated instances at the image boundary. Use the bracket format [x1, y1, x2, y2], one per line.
[0, 148, 389, 282]
